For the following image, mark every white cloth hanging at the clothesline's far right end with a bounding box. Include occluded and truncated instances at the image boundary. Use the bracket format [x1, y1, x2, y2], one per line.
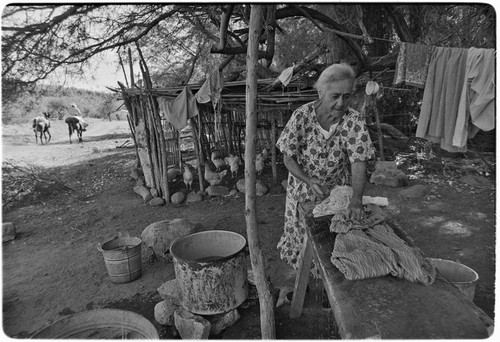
[453, 48, 495, 146]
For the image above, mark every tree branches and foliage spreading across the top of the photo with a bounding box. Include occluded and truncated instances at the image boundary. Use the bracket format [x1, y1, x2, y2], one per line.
[2, 3, 496, 103]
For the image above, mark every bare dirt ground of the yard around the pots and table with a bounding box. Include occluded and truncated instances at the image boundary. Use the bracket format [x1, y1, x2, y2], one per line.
[2, 119, 496, 339]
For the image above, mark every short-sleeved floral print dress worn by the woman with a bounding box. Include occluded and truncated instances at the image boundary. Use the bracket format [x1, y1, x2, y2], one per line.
[276, 102, 374, 273]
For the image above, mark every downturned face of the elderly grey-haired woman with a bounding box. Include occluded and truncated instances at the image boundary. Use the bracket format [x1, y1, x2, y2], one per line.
[319, 79, 354, 117]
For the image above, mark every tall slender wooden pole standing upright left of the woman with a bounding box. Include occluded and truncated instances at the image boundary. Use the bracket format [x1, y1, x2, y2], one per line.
[245, 5, 276, 340]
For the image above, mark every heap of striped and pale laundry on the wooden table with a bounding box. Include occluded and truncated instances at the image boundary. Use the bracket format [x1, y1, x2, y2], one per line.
[313, 186, 436, 285]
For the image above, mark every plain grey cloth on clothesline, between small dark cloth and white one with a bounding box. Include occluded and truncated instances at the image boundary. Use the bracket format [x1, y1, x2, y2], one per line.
[416, 47, 467, 152]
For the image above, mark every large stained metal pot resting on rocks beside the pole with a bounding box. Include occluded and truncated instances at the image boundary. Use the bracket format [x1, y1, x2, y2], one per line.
[170, 230, 248, 315]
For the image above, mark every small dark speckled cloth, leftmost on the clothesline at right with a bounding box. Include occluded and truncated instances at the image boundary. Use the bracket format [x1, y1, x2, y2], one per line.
[393, 43, 435, 88]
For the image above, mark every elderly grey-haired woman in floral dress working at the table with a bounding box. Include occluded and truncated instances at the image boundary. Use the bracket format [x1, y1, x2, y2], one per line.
[276, 64, 373, 269]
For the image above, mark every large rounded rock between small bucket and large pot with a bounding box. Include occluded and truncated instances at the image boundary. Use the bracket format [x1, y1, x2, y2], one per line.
[141, 219, 201, 257]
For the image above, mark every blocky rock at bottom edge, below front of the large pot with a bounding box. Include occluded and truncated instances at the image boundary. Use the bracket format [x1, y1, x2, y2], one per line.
[174, 307, 211, 340]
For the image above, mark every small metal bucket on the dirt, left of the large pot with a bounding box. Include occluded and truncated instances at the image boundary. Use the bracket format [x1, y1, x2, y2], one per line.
[97, 237, 142, 284]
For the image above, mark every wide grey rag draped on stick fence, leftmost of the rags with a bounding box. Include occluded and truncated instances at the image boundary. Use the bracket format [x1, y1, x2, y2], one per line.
[158, 87, 198, 131]
